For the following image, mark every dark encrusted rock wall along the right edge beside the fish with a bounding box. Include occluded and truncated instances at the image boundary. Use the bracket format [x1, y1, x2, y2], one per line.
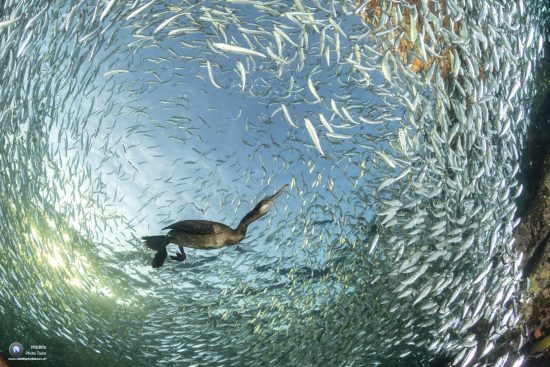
[516, 36, 550, 366]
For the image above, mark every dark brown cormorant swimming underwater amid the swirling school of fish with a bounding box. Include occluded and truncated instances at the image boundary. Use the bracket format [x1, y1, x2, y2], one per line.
[142, 184, 288, 268]
